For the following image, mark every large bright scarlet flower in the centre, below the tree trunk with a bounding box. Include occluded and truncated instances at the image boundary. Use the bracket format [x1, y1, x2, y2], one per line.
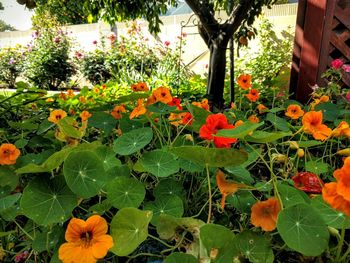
[199, 113, 237, 148]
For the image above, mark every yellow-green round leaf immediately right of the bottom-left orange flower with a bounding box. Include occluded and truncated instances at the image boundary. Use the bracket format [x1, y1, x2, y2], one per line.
[110, 207, 152, 256]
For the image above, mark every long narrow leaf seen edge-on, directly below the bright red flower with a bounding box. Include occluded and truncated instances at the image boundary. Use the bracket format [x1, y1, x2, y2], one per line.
[169, 146, 248, 167]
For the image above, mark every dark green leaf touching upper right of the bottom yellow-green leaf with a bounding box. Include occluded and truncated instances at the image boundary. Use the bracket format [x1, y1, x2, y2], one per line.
[144, 195, 184, 225]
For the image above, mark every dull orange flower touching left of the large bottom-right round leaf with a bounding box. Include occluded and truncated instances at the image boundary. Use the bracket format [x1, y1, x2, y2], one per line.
[251, 197, 281, 231]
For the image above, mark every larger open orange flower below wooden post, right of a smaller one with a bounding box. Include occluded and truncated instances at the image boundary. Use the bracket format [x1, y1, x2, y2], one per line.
[302, 111, 332, 141]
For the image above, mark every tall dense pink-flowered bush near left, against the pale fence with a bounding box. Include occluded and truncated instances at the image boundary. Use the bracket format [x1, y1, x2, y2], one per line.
[25, 27, 75, 90]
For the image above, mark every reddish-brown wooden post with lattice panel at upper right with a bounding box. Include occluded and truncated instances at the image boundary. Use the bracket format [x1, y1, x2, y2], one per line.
[290, 0, 350, 102]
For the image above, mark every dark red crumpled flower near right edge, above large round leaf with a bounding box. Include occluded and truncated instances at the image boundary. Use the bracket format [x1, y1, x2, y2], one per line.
[292, 172, 324, 194]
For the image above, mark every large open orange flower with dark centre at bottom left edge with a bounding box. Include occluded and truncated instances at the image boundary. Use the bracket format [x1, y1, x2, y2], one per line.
[58, 215, 113, 263]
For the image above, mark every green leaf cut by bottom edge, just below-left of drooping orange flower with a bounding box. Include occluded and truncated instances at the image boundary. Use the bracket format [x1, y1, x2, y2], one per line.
[234, 231, 274, 263]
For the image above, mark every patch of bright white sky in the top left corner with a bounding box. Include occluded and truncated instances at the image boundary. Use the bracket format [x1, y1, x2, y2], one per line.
[0, 0, 33, 30]
